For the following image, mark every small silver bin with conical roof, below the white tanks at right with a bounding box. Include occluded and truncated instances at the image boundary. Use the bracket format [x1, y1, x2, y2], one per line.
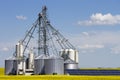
[64, 59, 78, 69]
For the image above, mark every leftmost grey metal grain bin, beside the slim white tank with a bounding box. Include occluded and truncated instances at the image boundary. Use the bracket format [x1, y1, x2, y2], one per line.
[5, 57, 17, 75]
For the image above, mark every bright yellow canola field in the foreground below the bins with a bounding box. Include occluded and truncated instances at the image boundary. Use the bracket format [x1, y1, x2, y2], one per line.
[0, 68, 120, 80]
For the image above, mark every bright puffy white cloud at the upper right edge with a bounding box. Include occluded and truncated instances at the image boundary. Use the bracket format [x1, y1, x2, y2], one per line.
[78, 13, 120, 26]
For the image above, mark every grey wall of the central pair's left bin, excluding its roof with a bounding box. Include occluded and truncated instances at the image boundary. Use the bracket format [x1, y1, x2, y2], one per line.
[34, 59, 45, 74]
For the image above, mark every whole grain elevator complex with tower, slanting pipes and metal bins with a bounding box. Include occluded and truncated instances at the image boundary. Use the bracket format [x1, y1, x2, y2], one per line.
[5, 6, 78, 75]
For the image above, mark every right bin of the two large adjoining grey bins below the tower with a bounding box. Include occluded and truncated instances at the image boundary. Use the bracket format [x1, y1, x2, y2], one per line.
[45, 55, 64, 75]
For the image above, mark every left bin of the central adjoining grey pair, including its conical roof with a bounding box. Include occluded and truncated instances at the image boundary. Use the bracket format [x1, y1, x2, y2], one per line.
[34, 54, 47, 75]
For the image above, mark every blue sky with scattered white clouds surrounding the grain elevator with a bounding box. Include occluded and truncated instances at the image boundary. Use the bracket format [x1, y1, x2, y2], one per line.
[0, 0, 120, 68]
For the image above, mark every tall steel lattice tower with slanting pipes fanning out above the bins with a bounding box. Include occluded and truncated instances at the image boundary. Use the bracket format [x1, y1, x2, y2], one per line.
[13, 6, 76, 72]
